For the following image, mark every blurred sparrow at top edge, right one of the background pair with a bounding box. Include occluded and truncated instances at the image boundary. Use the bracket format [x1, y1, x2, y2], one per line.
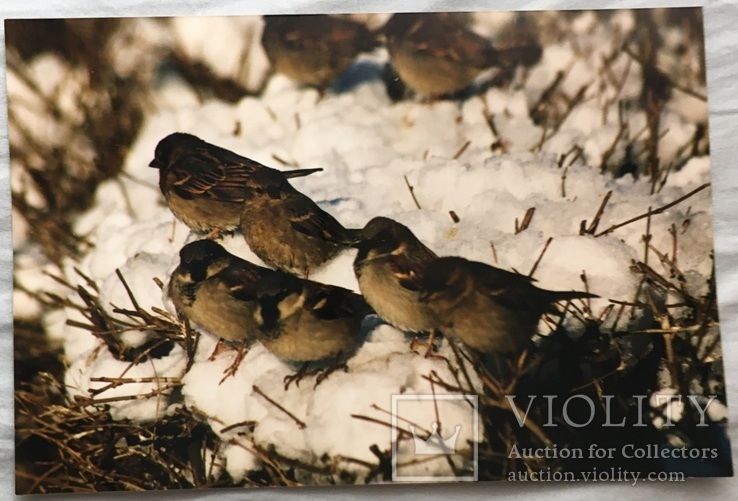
[382, 13, 541, 98]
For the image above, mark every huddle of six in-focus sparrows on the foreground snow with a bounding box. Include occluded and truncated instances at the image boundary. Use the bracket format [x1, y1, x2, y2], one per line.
[150, 133, 596, 382]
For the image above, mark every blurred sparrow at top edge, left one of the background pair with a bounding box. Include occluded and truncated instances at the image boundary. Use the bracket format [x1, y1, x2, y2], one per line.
[261, 15, 379, 90]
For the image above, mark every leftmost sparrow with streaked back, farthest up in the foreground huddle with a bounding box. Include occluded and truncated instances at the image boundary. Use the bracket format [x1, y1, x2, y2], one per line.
[149, 132, 323, 238]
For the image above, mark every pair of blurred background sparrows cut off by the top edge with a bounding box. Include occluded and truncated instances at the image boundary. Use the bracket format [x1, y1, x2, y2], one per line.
[262, 13, 542, 98]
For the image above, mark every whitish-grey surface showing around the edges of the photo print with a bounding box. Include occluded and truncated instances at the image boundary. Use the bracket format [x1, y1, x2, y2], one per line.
[0, 0, 738, 501]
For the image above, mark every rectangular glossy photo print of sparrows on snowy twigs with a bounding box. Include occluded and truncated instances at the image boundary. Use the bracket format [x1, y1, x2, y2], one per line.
[5, 8, 732, 494]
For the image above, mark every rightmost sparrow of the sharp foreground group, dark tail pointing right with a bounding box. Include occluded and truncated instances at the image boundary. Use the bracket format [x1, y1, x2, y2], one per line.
[420, 257, 598, 356]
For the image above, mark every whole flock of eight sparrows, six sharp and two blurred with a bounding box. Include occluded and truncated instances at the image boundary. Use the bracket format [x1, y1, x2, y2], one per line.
[150, 9, 568, 384]
